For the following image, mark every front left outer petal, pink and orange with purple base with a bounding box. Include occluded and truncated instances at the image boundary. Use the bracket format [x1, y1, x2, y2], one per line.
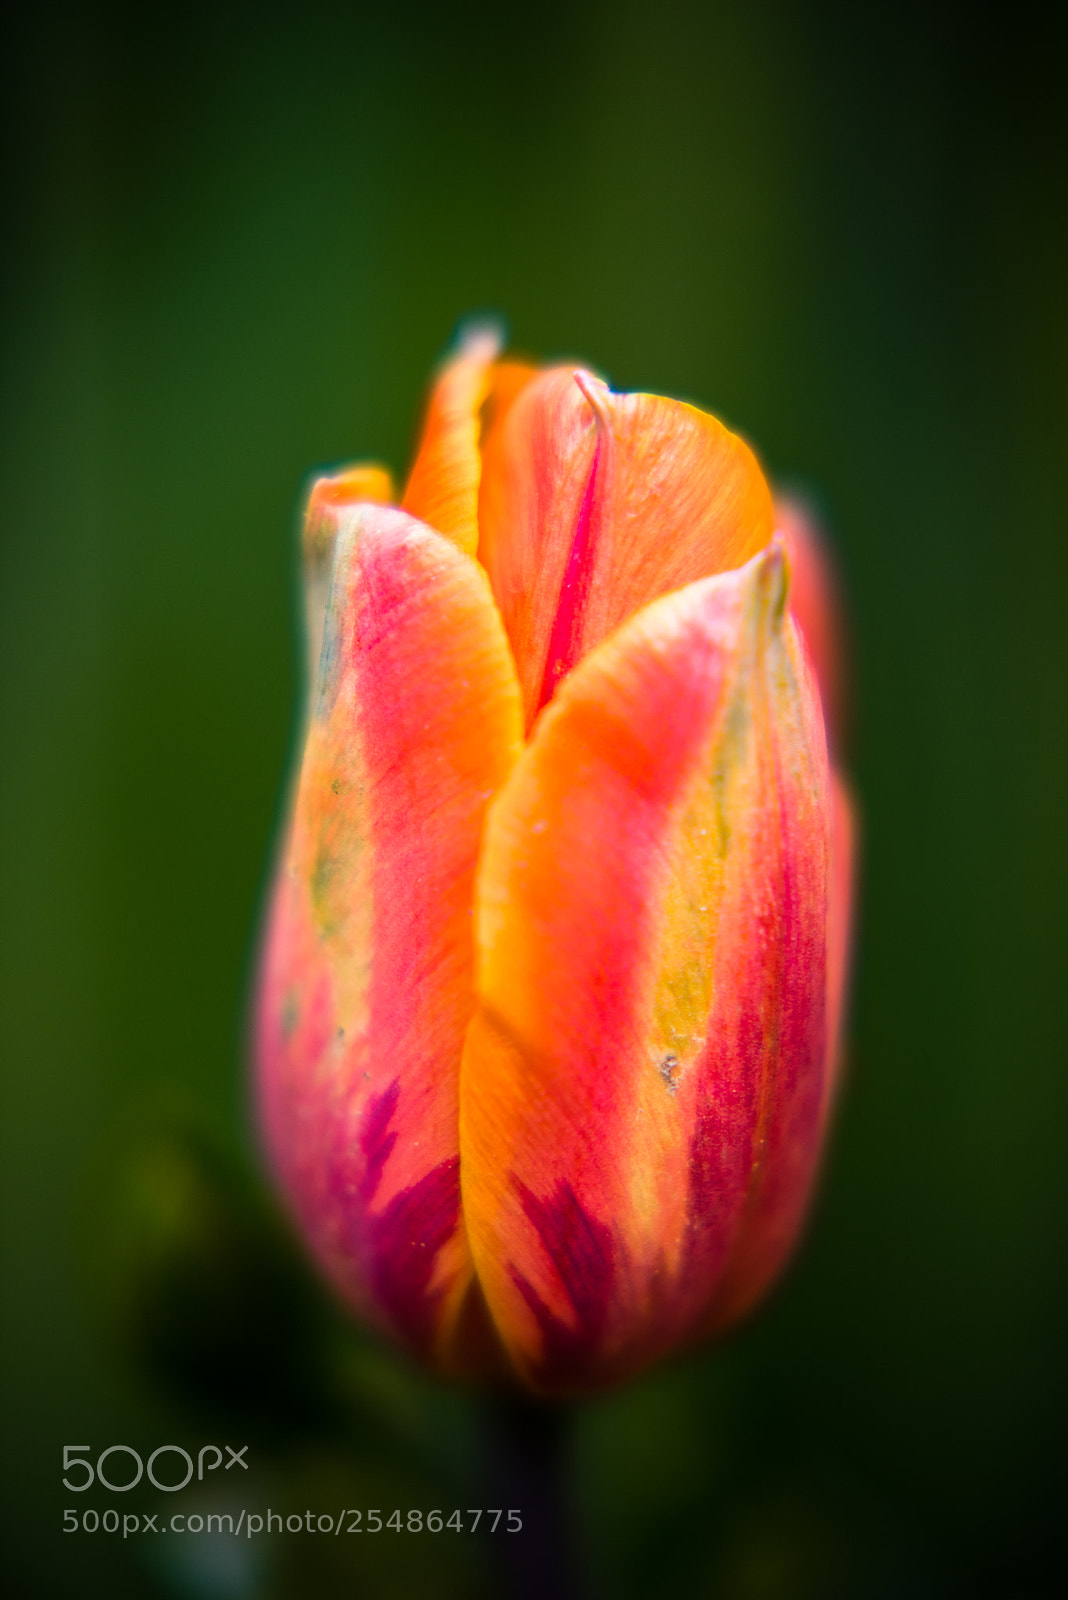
[257, 506, 521, 1365]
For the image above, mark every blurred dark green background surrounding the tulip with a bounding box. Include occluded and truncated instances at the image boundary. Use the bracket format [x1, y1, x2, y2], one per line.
[0, 0, 1068, 1600]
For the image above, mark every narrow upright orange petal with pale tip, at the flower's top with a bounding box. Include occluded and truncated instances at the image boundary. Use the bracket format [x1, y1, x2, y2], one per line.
[401, 328, 500, 555]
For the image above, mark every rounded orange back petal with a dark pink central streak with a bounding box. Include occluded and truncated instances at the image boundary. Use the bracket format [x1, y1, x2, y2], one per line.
[478, 368, 774, 726]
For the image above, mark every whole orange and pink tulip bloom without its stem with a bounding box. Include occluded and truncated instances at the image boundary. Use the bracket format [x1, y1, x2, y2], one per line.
[256, 331, 851, 1394]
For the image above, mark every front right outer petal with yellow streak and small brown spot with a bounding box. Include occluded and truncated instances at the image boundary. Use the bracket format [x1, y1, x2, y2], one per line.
[460, 544, 828, 1390]
